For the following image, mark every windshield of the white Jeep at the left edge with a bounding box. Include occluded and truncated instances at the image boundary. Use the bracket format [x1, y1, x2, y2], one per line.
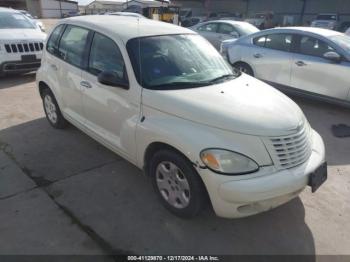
[0, 12, 35, 29]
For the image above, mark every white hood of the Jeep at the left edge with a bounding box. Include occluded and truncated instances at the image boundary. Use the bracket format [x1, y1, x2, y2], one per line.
[0, 29, 46, 41]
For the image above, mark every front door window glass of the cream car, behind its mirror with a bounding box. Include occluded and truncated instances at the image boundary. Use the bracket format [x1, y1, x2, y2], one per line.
[88, 33, 127, 81]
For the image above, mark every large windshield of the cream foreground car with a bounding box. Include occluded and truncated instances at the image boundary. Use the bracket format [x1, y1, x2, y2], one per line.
[127, 34, 239, 90]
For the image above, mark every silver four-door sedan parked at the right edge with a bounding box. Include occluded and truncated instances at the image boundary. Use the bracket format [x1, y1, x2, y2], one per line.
[227, 27, 350, 105]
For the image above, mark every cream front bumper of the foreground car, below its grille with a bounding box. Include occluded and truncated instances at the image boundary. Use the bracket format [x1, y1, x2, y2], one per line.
[198, 131, 325, 218]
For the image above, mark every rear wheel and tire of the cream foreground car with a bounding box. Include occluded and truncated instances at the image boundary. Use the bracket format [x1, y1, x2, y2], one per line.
[42, 88, 68, 129]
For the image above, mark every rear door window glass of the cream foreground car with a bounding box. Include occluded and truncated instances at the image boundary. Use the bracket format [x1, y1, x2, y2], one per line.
[58, 25, 89, 67]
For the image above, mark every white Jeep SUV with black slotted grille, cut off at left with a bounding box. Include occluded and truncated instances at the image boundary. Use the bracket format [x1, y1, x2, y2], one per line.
[0, 7, 46, 76]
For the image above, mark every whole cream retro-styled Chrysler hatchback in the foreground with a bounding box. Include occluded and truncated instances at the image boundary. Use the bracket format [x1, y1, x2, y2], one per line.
[37, 16, 327, 218]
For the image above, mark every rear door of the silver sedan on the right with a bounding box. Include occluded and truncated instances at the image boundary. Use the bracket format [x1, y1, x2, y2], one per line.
[248, 33, 293, 85]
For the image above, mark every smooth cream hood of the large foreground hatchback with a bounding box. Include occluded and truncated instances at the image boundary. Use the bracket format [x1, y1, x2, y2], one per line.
[142, 74, 305, 136]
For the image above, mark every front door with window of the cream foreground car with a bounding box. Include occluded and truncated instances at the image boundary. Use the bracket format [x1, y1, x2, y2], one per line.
[81, 33, 141, 158]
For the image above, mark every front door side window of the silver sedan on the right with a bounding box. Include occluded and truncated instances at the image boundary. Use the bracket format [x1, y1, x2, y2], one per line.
[300, 36, 334, 57]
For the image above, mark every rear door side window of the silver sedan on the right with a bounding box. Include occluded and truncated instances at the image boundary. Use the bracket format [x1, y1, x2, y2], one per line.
[254, 34, 293, 52]
